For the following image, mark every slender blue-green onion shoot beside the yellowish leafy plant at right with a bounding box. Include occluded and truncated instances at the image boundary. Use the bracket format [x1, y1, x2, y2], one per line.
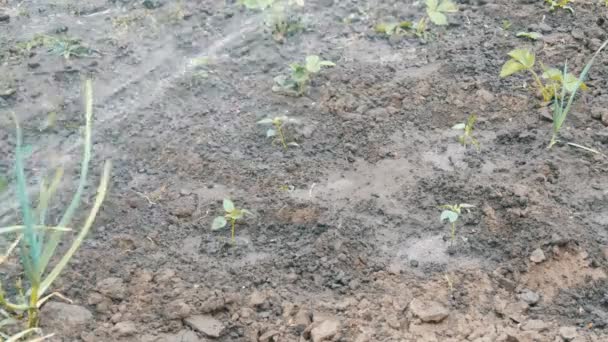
[548, 40, 608, 149]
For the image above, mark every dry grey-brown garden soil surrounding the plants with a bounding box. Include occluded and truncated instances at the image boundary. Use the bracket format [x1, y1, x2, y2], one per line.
[0, 0, 608, 342]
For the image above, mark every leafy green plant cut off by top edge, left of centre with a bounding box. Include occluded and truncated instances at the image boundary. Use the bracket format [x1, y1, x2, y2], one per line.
[240, 0, 304, 43]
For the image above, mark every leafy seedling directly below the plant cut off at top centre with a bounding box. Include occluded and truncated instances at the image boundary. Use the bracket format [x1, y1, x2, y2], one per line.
[272, 55, 336, 96]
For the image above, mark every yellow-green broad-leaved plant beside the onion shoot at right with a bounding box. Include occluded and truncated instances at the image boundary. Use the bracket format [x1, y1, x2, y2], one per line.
[500, 49, 587, 102]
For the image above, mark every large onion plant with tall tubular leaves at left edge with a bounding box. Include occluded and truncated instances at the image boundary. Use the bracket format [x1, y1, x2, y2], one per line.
[0, 80, 111, 328]
